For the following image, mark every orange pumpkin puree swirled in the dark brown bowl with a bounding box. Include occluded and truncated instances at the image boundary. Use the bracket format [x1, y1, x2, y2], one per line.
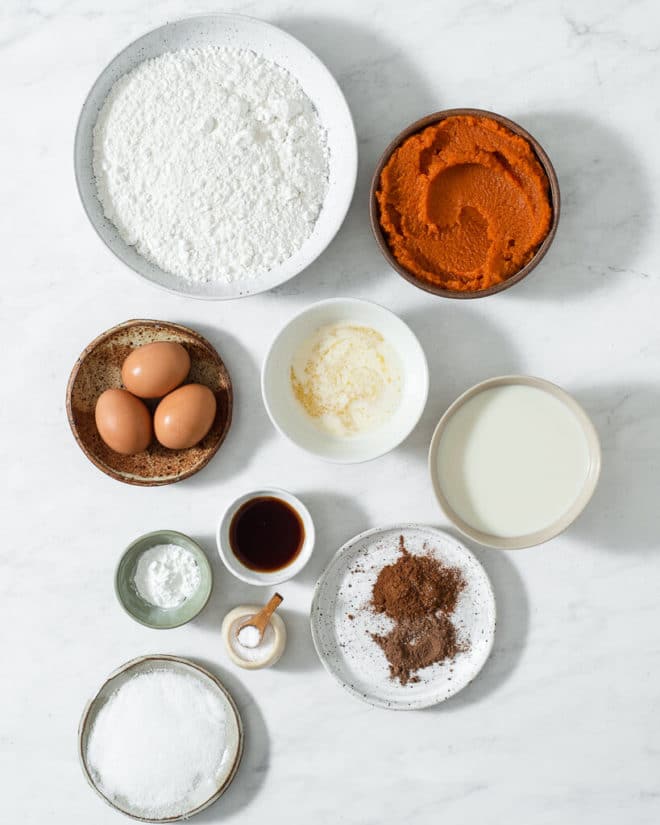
[376, 115, 552, 292]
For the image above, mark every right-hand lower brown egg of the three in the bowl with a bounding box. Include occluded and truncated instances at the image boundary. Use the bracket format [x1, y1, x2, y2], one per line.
[154, 384, 216, 450]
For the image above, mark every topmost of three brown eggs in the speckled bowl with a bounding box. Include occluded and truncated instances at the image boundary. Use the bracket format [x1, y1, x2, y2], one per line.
[121, 341, 190, 398]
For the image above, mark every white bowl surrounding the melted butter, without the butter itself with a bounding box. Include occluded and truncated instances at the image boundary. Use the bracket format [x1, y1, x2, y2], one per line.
[261, 298, 429, 464]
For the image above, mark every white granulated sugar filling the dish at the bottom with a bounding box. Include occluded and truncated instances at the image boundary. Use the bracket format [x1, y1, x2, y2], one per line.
[86, 670, 226, 818]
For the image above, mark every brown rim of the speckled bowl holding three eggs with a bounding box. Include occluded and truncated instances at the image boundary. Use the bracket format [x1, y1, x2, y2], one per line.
[66, 318, 234, 487]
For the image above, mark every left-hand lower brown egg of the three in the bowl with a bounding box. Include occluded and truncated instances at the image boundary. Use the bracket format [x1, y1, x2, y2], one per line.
[94, 390, 153, 455]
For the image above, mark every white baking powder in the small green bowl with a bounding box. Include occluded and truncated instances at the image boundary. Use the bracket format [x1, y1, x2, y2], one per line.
[133, 544, 201, 609]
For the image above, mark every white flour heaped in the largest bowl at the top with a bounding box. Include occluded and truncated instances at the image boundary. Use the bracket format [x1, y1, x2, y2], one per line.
[93, 47, 328, 282]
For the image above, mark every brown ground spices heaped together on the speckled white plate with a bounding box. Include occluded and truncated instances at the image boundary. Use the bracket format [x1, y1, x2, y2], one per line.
[372, 536, 466, 685]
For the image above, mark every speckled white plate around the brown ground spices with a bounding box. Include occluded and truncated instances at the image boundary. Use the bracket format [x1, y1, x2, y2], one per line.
[311, 524, 495, 710]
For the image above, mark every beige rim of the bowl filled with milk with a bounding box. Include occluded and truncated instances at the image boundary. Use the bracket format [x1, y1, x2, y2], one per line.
[427, 375, 602, 550]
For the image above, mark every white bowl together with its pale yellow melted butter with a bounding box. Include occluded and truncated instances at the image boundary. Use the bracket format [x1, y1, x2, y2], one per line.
[261, 298, 429, 464]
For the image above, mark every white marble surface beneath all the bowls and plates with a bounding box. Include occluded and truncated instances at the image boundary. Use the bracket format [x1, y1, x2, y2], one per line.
[0, 0, 660, 825]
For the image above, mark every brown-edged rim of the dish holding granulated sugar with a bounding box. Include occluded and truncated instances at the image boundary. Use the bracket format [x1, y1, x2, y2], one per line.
[78, 653, 245, 823]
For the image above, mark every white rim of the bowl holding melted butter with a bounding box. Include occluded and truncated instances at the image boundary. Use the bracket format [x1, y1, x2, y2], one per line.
[261, 297, 431, 465]
